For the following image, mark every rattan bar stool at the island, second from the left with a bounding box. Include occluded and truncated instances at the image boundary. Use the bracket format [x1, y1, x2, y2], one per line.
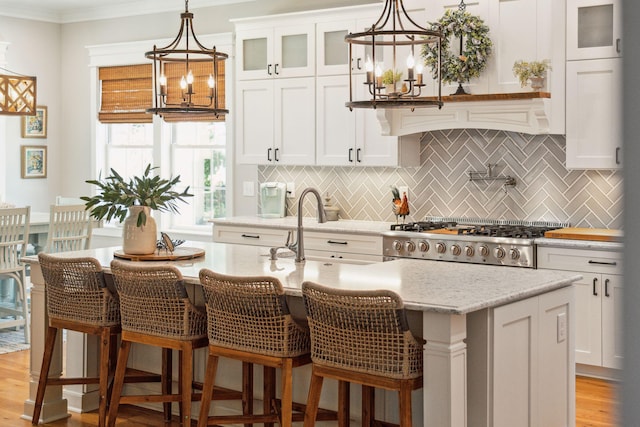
[108, 260, 207, 427]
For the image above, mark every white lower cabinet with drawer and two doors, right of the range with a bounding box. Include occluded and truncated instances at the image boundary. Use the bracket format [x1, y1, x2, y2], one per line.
[538, 247, 623, 369]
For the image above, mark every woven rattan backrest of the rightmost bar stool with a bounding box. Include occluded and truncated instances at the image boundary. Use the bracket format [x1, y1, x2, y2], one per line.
[302, 282, 423, 379]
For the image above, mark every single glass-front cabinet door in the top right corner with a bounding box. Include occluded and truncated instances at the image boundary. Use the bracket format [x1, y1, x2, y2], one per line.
[567, 0, 622, 60]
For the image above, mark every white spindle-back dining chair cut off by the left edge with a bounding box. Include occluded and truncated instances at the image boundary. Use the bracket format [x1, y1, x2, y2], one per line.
[0, 206, 31, 343]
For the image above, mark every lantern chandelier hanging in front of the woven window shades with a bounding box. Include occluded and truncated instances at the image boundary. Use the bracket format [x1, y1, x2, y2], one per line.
[145, 0, 229, 118]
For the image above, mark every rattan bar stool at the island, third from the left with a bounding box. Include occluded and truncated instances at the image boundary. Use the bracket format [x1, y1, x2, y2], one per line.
[198, 269, 336, 427]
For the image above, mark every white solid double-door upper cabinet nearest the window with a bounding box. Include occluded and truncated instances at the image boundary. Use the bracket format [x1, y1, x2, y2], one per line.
[236, 77, 316, 165]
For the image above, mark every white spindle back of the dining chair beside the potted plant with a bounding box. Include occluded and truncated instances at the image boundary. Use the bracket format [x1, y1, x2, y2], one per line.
[44, 205, 92, 253]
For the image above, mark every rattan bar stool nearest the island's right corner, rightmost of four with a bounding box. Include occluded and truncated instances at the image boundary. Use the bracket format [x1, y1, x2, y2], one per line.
[302, 282, 423, 427]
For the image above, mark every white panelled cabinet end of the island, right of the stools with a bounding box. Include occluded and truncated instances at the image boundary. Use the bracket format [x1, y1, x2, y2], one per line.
[467, 287, 575, 427]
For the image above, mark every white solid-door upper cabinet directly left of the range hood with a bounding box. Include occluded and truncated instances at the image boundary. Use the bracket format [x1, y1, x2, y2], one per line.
[316, 75, 420, 166]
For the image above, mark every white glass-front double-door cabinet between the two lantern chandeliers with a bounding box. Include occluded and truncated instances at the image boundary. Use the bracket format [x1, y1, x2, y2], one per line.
[236, 24, 315, 80]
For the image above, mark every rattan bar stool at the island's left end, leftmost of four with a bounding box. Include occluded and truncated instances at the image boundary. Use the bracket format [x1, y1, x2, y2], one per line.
[31, 252, 160, 427]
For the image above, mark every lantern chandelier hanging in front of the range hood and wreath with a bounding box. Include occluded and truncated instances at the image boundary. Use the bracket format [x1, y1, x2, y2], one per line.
[344, 0, 442, 110]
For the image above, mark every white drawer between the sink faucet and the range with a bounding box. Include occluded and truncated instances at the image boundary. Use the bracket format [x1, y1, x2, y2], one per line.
[304, 231, 382, 256]
